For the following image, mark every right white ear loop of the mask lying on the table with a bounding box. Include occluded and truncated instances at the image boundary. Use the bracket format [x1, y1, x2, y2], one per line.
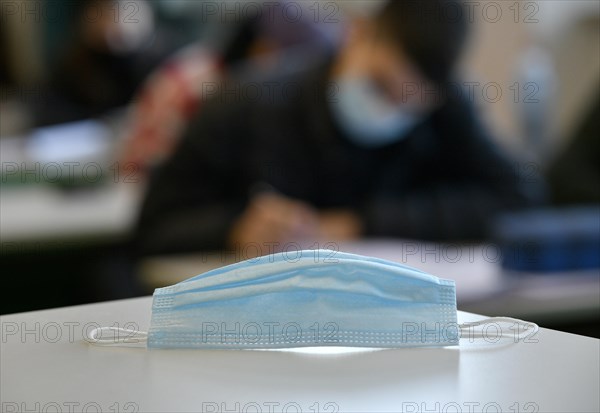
[458, 317, 540, 346]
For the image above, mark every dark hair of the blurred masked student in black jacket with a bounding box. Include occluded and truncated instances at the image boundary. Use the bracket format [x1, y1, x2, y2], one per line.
[375, 0, 469, 83]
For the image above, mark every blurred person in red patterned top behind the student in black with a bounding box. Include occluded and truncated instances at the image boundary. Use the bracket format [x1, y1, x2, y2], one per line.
[120, 1, 338, 172]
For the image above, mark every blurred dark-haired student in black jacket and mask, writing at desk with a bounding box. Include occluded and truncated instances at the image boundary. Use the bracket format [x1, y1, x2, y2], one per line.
[137, 0, 538, 254]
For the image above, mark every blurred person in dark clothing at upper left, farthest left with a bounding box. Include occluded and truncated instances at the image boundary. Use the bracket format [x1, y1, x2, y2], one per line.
[33, 0, 172, 126]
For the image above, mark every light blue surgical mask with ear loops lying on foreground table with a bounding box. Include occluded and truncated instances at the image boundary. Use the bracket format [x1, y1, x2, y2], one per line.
[87, 250, 537, 349]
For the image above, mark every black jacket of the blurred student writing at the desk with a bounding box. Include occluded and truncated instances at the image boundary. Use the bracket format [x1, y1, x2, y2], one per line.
[137, 58, 540, 254]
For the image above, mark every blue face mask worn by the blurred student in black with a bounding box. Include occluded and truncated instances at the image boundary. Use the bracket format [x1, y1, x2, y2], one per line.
[331, 76, 420, 148]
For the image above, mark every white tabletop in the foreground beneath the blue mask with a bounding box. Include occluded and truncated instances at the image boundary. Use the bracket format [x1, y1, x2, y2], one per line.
[0, 297, 600, 412]
